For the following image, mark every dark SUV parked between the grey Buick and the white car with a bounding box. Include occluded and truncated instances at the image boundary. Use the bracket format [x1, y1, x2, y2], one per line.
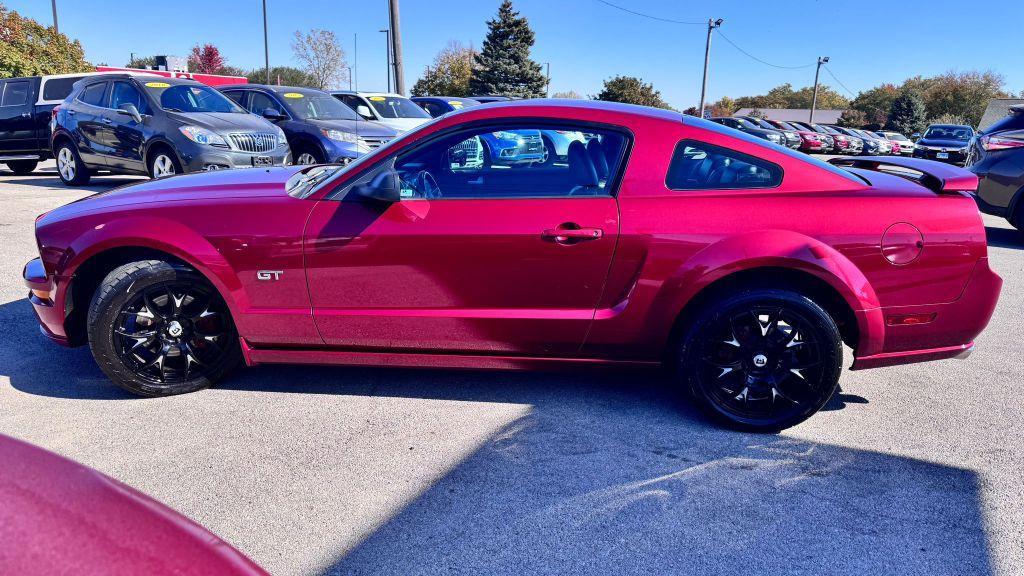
[219, 84, 397, 164]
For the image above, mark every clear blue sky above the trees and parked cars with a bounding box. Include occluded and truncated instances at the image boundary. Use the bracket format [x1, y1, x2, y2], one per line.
[0, 0, 1024, 109]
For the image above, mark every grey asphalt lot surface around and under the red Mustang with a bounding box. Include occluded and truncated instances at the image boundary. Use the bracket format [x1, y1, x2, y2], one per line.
[0, 157, 1024, 575]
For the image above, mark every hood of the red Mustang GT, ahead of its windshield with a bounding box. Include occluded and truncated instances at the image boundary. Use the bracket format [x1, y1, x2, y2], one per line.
[40, 166, 303, 223]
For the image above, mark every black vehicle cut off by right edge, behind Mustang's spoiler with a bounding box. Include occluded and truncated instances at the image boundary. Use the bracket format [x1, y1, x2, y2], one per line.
[967, 107, 1024, 230]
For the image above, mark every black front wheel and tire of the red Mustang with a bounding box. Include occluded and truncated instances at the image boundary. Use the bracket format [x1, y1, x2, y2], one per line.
[88, 260, 242, 397]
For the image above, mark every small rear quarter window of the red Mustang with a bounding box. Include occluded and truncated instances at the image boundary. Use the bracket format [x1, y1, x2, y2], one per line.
[666, 140, 782, 190]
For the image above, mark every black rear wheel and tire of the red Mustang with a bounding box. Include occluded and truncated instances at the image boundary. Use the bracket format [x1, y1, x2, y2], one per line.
[678, 289, 843, 431]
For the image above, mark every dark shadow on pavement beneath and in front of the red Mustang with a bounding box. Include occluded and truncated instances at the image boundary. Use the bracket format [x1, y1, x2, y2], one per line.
[0, 300, 992, 576]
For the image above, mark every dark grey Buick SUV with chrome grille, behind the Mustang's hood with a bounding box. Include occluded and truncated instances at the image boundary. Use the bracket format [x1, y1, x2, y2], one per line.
[50, 74, 289, 186]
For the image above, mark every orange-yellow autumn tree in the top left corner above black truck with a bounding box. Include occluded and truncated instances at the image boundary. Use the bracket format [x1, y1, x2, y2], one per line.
[0, 4, 94, 78]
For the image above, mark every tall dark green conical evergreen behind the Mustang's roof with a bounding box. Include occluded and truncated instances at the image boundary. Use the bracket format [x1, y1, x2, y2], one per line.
[469, 0, 547, 98]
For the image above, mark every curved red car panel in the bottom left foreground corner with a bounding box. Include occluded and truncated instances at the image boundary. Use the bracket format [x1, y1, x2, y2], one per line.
[0, 436, 266, 576]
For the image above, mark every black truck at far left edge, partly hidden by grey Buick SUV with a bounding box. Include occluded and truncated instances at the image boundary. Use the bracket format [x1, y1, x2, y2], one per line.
[0, 72, 146, 175]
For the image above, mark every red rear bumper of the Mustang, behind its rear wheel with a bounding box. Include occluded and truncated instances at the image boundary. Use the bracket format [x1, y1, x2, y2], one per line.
[850, 258, 1002, 370]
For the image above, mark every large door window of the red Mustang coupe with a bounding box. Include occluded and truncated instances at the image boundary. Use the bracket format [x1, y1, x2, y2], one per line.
[395, 123, 628, 199]
